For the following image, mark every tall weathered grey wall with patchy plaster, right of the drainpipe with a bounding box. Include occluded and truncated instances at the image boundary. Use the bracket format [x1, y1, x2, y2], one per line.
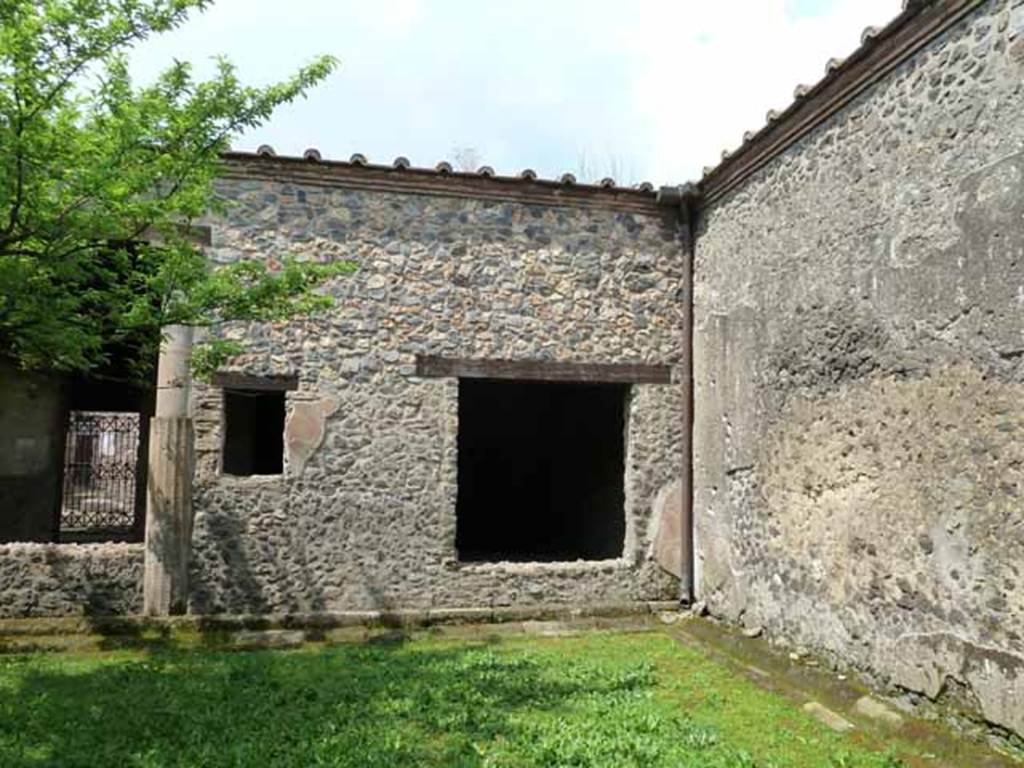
[694, 0, 1024, 733]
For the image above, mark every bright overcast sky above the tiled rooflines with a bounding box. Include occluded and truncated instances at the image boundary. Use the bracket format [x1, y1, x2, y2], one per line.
[133, 0, 900, 184]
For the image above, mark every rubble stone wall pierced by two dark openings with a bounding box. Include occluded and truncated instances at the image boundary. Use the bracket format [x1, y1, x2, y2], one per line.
[190, 171, 683, 612]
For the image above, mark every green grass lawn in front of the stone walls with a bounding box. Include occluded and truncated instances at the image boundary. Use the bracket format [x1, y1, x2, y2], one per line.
[0, 633, 902, 768]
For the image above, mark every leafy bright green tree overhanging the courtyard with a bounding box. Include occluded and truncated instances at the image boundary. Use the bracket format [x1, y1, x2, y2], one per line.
[0, 0, 351, 373]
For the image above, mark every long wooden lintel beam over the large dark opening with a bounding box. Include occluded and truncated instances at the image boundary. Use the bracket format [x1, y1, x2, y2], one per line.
[416, 354, 672, 384]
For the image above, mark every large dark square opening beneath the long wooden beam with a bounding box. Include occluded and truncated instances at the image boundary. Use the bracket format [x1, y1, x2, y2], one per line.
[456, 379, 629, 561]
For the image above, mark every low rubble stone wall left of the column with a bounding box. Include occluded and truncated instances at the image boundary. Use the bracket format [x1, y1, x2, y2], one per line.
[0, 544, 142, 618]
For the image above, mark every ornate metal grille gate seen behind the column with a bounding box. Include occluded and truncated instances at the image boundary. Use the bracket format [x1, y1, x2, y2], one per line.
[60, 411, 140, 532]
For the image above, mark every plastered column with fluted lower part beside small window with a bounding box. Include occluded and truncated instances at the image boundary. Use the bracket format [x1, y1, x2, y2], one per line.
[143, 326, 194, 615]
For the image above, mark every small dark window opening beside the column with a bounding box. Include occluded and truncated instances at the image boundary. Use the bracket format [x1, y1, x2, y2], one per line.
[223, 389, 285, 476]
